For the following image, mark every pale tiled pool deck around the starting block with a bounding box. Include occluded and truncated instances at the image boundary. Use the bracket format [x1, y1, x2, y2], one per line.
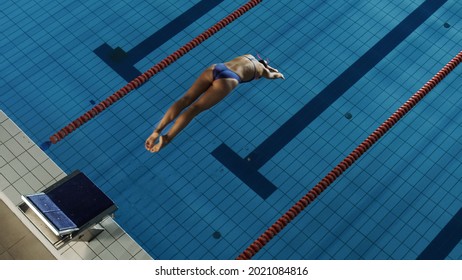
[0, 110, 152, 260]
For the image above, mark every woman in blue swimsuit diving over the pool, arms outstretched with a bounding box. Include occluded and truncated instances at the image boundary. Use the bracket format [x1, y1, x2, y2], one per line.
[145, 54, 284, 153]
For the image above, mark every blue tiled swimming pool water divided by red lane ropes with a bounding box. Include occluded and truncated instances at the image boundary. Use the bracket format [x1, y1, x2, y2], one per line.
[0, 0, 462, 259]
